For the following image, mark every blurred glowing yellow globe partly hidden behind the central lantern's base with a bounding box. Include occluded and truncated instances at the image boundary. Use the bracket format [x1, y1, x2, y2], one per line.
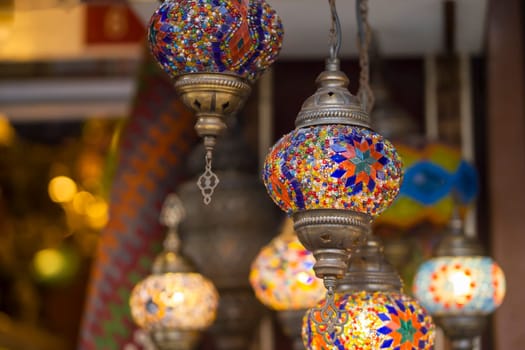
[250, 228, 325, 311]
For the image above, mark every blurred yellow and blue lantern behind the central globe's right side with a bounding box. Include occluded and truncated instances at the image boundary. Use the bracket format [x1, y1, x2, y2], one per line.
[376, 143, 478, 230]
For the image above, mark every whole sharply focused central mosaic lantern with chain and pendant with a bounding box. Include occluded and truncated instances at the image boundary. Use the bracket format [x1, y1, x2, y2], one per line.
[263, 0, 402, 332]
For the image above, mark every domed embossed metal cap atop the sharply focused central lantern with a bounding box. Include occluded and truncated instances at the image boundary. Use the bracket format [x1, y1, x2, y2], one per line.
[295, 69, 371, 129]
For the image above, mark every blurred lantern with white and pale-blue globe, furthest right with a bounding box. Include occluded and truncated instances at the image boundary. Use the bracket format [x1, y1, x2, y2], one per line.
[413, 216, 505, 350]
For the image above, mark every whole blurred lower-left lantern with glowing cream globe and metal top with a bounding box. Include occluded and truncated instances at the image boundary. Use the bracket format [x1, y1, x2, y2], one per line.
[129, 194, 219, 350]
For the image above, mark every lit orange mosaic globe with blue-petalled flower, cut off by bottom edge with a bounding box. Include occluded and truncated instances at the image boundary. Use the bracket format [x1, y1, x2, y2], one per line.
[302, 291, 435, 350]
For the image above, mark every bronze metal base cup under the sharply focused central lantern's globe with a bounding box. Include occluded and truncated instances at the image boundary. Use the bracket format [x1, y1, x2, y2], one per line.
[293, 209, 371, 279]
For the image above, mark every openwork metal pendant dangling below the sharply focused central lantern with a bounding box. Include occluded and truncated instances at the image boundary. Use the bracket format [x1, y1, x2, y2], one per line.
[312, 278, 348, 344]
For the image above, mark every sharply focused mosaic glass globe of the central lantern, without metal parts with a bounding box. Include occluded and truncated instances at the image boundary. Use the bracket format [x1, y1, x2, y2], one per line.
[263, 125, 402, 217]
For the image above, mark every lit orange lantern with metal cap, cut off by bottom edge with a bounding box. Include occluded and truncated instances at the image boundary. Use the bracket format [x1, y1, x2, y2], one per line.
[302, 237, 435, 350]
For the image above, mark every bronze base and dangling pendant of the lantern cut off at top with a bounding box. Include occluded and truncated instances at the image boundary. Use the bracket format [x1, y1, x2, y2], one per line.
[175, 73, 251, 204]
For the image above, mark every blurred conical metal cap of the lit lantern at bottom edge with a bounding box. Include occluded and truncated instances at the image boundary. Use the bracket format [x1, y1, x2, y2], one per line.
[337, 235, 403, 293]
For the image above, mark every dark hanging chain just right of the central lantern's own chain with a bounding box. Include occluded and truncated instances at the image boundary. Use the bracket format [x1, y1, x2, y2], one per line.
[356, 0, 375, 113]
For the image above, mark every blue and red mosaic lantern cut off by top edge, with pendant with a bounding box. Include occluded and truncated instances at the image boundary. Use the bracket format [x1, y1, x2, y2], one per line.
[148, 0, 283, 203]
